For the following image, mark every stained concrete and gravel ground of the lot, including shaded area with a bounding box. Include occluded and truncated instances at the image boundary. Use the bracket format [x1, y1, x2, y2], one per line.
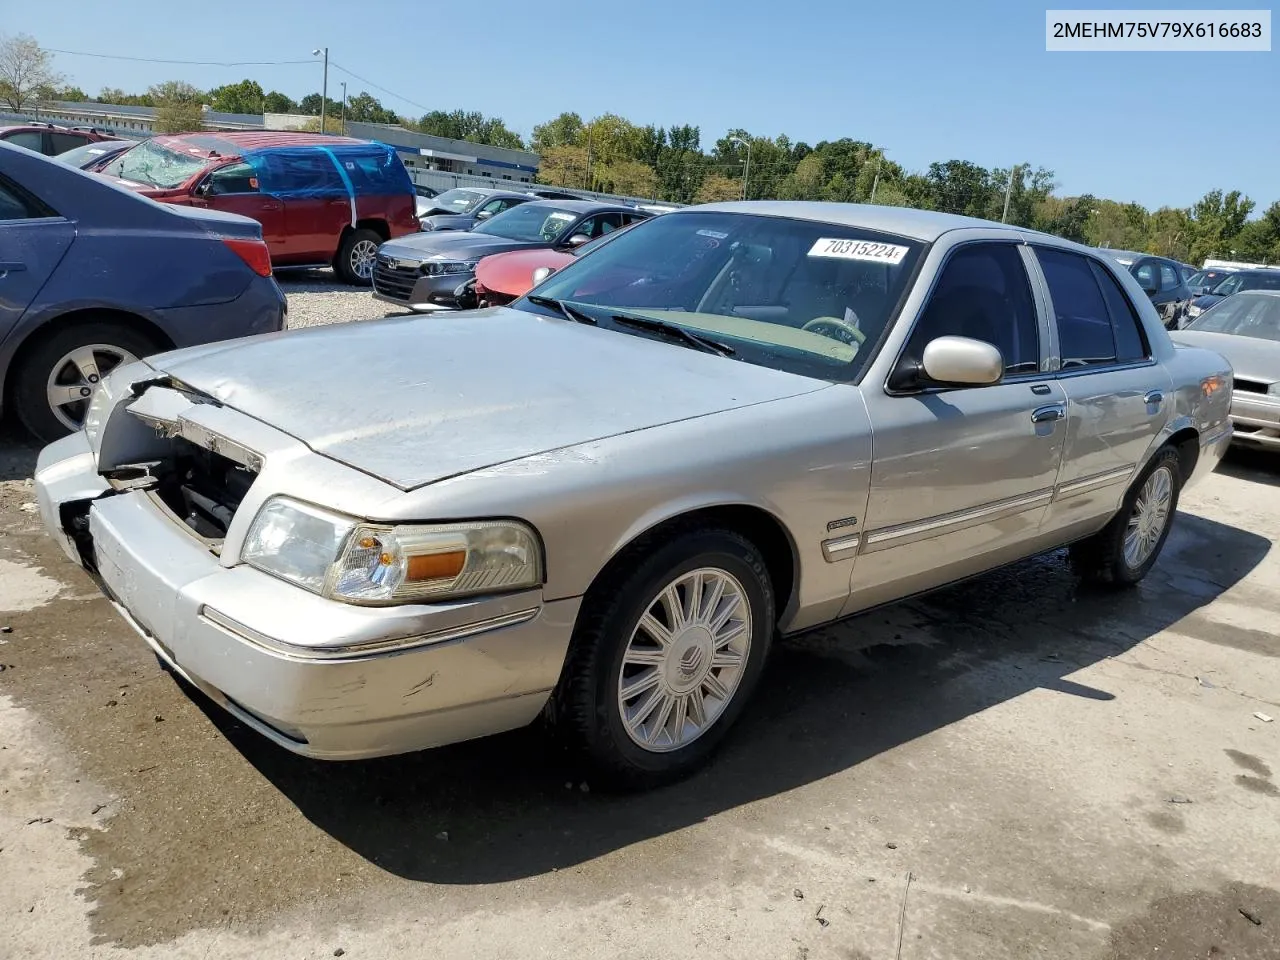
[0, 289, 1280, 960]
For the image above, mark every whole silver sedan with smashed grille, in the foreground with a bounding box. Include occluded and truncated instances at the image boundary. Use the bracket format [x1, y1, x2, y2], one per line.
[36, 202, 1231, 786]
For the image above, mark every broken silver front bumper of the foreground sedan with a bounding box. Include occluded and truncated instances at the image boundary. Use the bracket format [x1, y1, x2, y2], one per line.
[36, 419, 579, 759]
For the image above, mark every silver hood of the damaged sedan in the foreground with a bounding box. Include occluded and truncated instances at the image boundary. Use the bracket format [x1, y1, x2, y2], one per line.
[148, 307, 828, 490]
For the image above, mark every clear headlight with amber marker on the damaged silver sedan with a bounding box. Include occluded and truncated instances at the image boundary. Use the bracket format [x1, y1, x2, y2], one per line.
[241, 497, 543, 605]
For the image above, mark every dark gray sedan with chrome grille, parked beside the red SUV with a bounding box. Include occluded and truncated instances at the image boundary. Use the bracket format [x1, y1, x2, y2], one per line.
[374, 195, 653, 310]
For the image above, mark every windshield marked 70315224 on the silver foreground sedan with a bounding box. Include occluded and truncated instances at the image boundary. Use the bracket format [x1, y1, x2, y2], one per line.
[514, 211, 924, 380]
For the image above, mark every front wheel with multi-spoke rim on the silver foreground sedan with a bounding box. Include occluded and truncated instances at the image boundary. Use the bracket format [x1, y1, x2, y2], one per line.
[553, 529, 774, 790]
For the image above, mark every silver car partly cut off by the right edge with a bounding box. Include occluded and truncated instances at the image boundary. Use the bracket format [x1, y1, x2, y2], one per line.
[1174, 291, 1280, 451]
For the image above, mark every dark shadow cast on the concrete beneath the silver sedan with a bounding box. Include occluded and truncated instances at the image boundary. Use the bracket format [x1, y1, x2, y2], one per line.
[196, 515, 1280, 883]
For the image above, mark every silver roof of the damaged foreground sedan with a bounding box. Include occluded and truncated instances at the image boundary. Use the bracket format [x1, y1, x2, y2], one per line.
[691, 200, 1059, 246]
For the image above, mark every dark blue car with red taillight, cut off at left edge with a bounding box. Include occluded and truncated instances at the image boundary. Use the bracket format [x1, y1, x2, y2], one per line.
[0, 143, 285, 443]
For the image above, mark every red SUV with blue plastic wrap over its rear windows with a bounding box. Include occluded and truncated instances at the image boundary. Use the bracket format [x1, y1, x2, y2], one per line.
[99, 131, 419, 284]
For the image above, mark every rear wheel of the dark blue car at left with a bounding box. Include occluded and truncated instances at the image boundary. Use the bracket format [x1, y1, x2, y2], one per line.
[13, 320, 160, 443]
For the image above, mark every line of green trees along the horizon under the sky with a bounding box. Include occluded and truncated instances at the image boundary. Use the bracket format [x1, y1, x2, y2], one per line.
[0, 35, 1280, 264]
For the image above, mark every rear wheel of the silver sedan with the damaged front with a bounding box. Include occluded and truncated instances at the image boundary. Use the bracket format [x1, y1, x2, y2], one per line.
[1070, 447, 1183, 588]
